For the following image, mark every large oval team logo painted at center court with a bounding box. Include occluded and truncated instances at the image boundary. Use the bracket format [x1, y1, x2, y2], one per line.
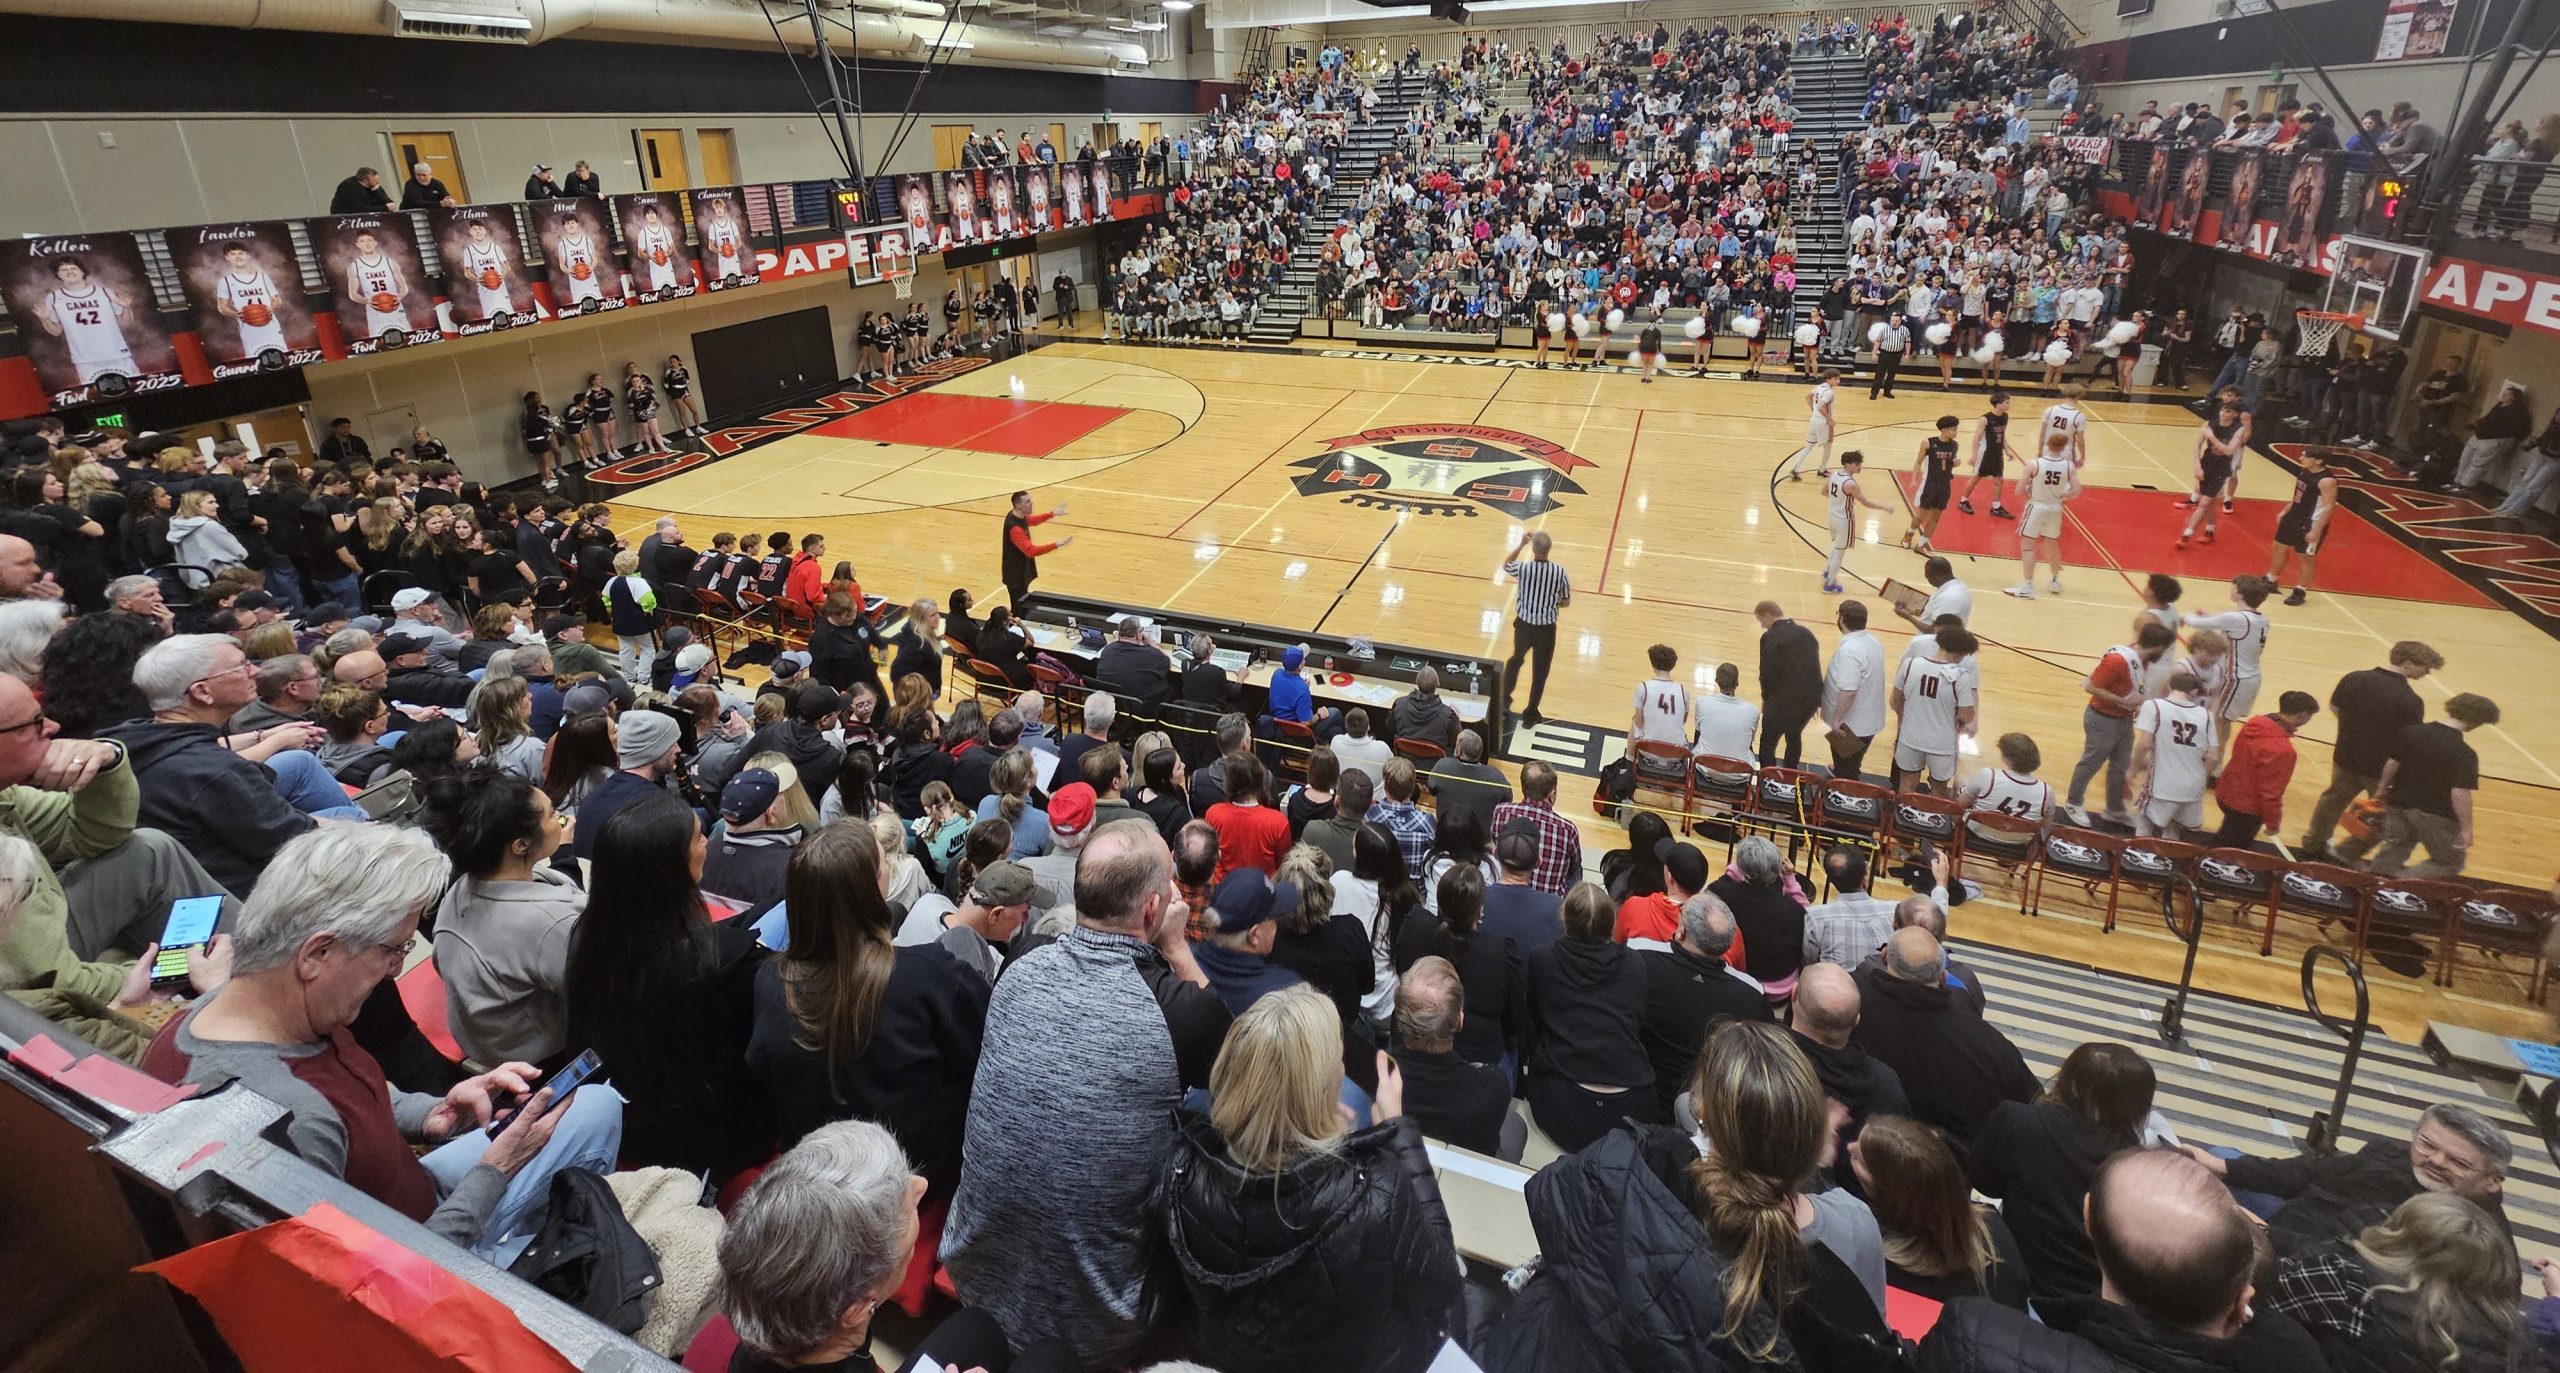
[1290, 425, 1597, 520]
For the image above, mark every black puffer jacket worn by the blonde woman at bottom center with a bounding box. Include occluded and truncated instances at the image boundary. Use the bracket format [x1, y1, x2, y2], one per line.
[1165, 1112, 1459, 1373]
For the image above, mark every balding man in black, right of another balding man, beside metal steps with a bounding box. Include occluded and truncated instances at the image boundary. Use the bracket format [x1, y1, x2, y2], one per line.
[1856, 930, 2038, 1148]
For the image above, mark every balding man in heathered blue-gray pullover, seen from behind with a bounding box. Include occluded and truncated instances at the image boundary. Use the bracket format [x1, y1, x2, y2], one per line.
[942, 820, 1231, 1365]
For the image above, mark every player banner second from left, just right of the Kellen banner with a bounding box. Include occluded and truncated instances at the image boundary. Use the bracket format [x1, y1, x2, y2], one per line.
[161, 220, 320, 382]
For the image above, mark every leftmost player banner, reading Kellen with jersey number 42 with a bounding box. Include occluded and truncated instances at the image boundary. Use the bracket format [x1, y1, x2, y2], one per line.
[0, 233, 187, 407]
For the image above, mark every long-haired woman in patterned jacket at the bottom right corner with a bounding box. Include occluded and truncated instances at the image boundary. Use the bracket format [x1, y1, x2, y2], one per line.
[2266, 1191, 2534, 1370]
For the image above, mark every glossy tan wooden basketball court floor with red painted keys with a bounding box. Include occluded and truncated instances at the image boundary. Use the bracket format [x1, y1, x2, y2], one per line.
[617, 341, 2560, 1037]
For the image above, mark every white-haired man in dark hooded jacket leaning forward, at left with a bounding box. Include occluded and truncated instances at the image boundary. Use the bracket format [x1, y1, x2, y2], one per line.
[97, 635, 364, 894]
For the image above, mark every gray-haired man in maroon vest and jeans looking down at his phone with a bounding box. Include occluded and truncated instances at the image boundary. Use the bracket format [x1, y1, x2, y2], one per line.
[143, 825, 622, 1265]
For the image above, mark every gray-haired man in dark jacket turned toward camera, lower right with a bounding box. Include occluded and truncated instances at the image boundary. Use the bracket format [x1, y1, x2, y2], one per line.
[2186, 1101, 2514, 1258]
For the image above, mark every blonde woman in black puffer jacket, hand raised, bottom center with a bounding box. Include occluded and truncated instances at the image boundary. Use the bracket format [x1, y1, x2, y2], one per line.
[1165, 988, 1462, 1373]
